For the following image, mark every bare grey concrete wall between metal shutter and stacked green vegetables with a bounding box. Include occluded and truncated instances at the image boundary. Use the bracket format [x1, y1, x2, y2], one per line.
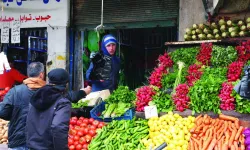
[178, 0, 206, 41]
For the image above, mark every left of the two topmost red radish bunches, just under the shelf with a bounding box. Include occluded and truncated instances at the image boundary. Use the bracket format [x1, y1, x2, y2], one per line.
[196, 43, 213, 65]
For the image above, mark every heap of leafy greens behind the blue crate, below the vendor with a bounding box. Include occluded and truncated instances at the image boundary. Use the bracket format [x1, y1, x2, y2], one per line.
[105, 86, 136, 104]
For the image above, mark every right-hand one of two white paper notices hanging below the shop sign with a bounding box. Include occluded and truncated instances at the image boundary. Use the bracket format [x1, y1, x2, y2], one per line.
[11, 20, 21, 43]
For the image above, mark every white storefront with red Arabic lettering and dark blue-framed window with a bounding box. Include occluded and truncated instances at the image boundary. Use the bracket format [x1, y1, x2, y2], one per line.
[0, 0, 69, 82]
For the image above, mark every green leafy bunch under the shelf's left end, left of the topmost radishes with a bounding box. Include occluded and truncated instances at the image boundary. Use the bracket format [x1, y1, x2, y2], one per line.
[169, 47, 199, 68]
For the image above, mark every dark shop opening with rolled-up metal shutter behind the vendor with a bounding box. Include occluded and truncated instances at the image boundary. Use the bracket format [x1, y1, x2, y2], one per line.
[73, 0, 179, 89]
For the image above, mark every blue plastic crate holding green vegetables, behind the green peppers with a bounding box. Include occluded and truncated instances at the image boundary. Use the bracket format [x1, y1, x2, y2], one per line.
[90, 102, 135, 122]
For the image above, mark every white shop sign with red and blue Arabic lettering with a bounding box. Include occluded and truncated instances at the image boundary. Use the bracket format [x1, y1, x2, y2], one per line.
[0, 0, 70, 28]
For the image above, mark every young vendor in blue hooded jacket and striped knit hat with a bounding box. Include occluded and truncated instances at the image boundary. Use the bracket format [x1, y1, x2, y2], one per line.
[86, 34, 120, 93]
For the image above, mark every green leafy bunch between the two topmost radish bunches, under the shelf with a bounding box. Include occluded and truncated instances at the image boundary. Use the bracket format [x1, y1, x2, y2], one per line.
[211, 45, 237, 67]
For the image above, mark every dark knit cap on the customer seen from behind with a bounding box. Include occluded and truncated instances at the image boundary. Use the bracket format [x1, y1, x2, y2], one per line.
[48, 68, 69, 85]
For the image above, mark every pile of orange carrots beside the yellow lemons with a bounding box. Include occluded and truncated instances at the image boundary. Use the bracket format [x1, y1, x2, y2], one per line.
[188, 114, 245, 150]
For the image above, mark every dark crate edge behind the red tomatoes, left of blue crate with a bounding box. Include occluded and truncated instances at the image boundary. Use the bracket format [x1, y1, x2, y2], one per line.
[71, 106, 94, 118]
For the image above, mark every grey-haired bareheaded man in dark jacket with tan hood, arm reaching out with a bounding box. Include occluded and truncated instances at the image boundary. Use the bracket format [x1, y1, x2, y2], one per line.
[0, 62, 91, 150]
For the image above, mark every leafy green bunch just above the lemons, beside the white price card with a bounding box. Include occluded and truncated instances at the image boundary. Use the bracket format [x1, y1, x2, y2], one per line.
[150, 91, 174, 112]
